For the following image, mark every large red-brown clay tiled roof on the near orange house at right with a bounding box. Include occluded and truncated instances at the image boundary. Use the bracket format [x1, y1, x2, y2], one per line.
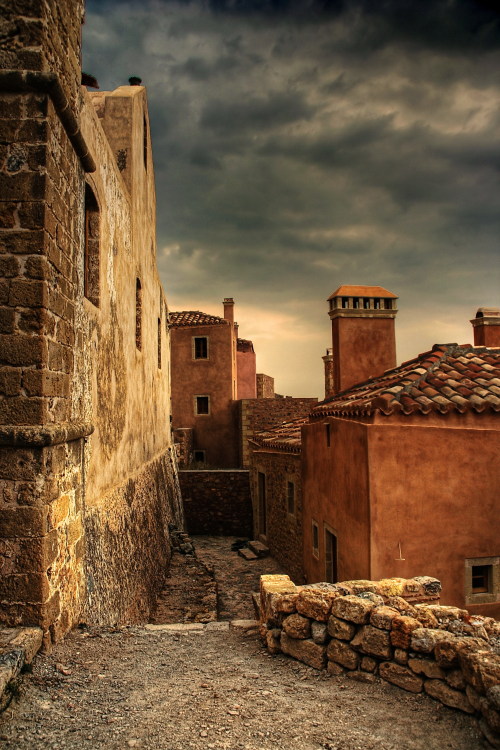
[311, 344, 500, 419]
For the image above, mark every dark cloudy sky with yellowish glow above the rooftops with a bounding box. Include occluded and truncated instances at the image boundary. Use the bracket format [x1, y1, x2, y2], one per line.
[83, 0, 500, 397]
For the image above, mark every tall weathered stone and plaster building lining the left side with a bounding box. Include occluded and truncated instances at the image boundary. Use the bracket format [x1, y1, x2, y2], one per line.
[0, 0, 182, 641]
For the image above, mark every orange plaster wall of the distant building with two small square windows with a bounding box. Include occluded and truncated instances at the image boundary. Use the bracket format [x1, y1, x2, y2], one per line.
[171, 323, 239, 468]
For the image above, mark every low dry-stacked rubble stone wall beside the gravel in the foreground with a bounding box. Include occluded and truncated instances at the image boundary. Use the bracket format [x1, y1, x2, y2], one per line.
[260, 576, 500, 748]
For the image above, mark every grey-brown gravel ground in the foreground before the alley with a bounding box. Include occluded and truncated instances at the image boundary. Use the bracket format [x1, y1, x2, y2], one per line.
[0, 627, 484, 750]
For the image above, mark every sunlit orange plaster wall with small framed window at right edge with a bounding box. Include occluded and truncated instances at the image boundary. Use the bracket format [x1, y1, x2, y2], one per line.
[368, 426, 500, 619]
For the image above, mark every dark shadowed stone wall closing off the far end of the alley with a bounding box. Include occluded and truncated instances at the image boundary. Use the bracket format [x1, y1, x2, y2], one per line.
[179, 469, 252, 537]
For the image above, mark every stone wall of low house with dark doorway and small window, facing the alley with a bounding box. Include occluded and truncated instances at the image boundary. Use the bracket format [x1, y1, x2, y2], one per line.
[250, 450, 304, 581]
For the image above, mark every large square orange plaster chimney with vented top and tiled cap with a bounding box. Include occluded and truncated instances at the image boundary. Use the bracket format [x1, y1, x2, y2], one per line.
[328, 286, 398, 393]
